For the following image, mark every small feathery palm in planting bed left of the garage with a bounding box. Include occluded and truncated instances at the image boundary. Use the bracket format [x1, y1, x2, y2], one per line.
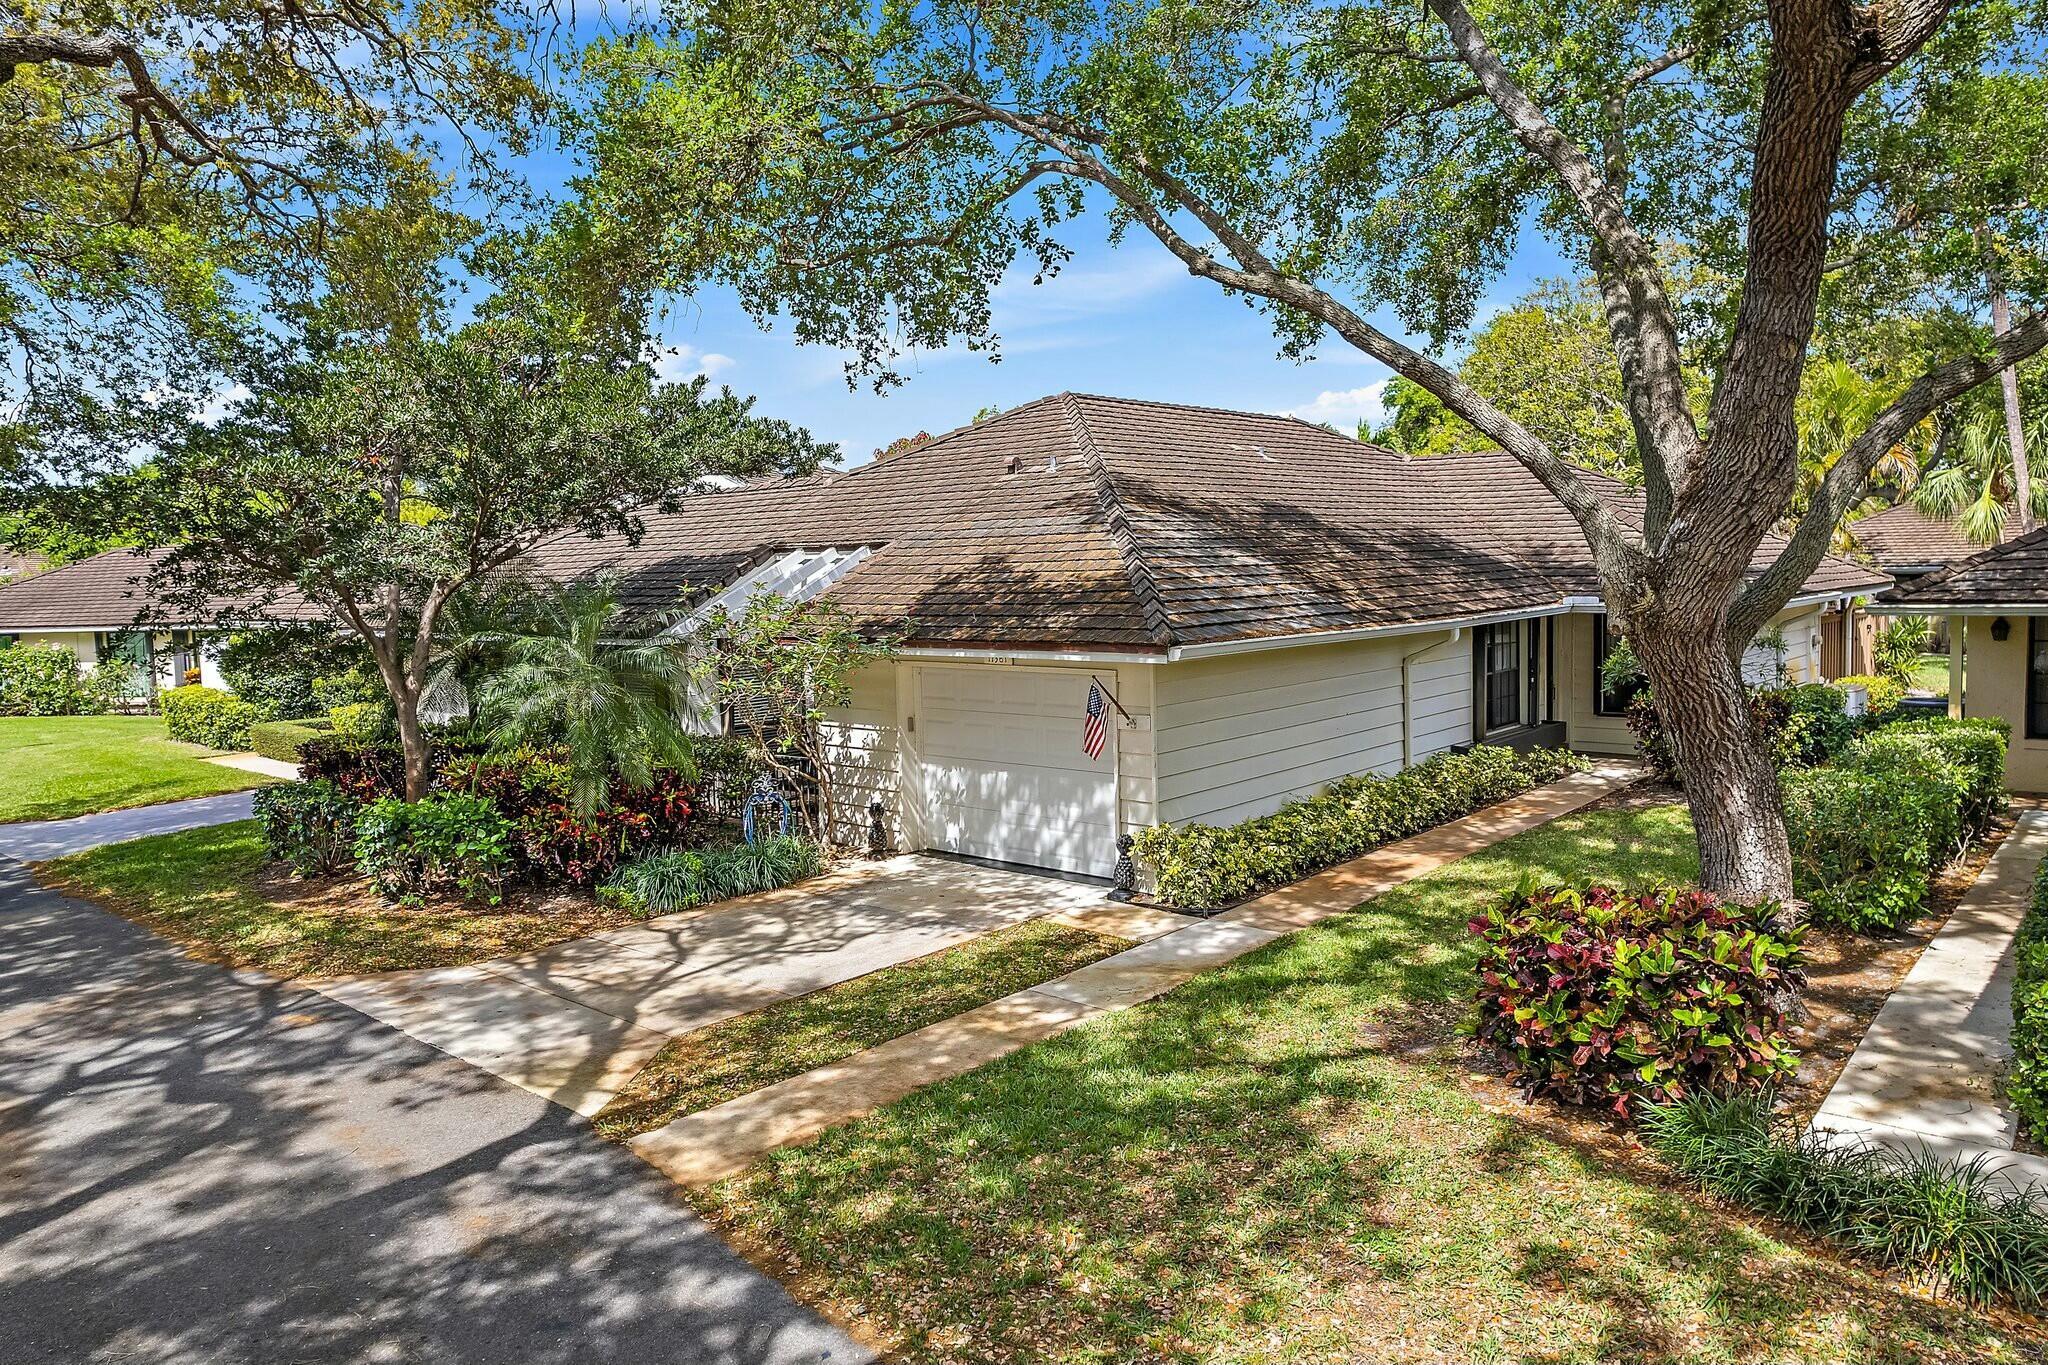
[477, 579, 694, 817]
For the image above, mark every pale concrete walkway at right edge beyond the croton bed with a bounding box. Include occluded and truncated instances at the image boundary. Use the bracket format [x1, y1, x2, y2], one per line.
[1812, 810, 2048, 1191]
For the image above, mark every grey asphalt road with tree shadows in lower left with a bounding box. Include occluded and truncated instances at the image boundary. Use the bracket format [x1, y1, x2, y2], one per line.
[0, 860, 870, 1365]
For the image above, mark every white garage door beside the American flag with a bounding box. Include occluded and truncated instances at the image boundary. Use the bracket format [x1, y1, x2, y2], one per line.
[918, 667, 1116, 876]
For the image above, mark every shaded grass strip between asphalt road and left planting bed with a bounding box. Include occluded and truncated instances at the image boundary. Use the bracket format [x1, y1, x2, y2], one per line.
[37, 821, 635, 976]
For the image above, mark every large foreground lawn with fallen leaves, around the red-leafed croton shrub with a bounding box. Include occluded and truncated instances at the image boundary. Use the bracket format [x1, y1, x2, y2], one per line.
[698, 806, 2044, 1365]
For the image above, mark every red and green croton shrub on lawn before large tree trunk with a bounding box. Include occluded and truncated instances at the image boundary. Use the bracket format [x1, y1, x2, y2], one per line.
[1470, 882, 1804, 1115]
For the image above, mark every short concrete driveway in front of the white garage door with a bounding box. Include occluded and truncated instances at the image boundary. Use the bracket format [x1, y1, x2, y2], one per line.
[305, 855, 1138, 1115]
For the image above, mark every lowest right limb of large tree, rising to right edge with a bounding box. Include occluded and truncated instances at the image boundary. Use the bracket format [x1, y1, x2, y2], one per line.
[1729, 309, 2048, 641]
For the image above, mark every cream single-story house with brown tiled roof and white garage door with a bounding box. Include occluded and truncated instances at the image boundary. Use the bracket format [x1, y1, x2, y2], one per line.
[0, 393, 1888, 876]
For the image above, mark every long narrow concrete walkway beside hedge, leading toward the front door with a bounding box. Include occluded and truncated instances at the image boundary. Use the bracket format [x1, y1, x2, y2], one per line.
[631, 761, 1642, 1185]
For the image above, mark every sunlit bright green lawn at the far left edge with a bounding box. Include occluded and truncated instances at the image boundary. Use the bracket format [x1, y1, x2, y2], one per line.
[0, 716, 270, 823]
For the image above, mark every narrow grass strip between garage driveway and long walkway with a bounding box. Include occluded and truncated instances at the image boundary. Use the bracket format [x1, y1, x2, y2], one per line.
[596, 919, 1130, 1140]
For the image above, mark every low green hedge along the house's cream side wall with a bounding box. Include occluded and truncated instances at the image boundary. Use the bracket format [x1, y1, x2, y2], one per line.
[1133, 745, 1585, 909]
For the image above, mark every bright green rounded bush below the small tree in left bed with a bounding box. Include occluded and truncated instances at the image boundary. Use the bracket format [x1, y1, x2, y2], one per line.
[354, 794, 514, 905]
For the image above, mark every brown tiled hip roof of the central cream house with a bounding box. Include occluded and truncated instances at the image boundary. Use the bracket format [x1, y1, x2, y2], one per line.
[0, 393, 1884, 651]
